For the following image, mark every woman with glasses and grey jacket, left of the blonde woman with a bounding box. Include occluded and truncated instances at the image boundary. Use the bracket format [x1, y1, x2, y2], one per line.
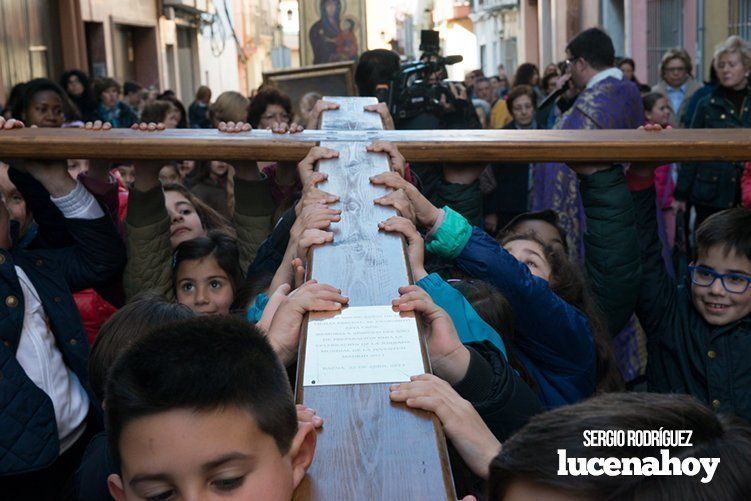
[652, 48, 702, 127]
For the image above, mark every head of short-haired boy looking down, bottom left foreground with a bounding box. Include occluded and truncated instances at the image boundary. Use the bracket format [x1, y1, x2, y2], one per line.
[106, 317, 316, 501]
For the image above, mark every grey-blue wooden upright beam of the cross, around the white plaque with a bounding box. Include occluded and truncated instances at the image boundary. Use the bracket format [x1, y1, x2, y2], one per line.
[296, 98, 456, 500]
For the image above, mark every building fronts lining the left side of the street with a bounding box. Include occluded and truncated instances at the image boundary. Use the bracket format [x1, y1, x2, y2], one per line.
[0, 0, 296, 108]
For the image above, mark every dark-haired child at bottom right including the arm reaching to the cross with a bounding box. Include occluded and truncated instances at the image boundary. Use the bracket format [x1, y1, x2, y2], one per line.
[390, 374, 751, 501]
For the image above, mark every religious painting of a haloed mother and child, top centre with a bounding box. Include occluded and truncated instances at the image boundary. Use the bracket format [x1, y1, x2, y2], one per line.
[299, 0, 367, 66]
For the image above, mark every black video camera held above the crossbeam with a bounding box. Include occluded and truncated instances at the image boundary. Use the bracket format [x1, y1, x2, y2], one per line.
[376, 30, 463, 128]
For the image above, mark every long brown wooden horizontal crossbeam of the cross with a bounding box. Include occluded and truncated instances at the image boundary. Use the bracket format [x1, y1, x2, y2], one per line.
[0, 129, 751, 163]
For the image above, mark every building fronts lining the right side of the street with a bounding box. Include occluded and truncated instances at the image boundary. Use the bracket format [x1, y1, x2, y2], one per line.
[470, 0, 751, 84]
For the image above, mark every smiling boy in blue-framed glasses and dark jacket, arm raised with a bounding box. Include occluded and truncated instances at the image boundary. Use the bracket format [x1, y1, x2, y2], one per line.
[629, 169, 751, 420]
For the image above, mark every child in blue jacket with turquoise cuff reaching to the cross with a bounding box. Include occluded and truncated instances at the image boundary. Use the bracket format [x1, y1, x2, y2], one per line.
[373, 173, 620, 408]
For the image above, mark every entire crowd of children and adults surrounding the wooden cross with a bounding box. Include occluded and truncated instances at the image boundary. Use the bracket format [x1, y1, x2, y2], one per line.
[0, 28, 751, 500]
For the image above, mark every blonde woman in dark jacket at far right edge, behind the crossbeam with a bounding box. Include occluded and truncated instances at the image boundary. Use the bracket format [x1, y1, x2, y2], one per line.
[675, 35, 751, 226]
